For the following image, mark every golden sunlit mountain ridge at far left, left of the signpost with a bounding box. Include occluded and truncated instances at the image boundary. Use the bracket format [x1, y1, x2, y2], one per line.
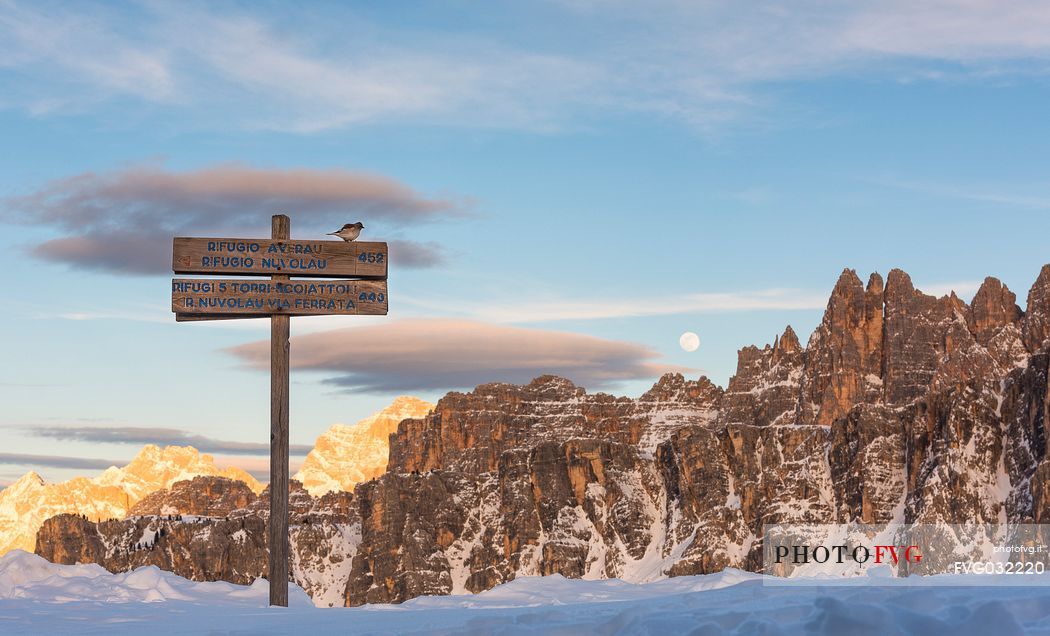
[0, 445, 263, 554]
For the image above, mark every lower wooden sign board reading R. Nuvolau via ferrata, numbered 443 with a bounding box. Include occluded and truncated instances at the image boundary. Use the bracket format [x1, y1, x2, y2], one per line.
[171, 278, 387, 321]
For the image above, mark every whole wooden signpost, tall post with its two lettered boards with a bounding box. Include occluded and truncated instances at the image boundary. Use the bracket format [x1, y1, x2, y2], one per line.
[171, 214, 389, 607]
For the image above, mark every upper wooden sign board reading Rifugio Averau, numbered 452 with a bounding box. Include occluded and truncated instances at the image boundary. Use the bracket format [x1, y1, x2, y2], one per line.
[171, 237, 390, 278]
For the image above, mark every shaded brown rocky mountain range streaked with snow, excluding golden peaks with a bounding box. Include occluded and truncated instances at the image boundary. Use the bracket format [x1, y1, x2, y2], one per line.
[28, 266, 1050, 606]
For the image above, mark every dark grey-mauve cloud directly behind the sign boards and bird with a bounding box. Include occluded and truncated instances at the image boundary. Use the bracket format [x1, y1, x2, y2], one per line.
[0, 164, 465, 274]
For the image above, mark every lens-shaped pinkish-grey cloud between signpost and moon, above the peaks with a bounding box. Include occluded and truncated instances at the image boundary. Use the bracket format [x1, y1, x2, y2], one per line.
[228, 319, 693, 393]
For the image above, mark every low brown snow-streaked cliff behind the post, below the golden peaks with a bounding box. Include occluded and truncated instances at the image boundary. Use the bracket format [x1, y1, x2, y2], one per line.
[36, 476, 360, 607]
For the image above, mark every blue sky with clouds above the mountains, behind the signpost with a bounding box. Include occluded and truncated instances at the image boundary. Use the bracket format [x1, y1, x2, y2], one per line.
[0, 0, 1050, 482]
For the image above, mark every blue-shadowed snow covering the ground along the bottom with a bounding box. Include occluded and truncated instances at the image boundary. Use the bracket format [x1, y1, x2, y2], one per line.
[0, 551, 1050, 636]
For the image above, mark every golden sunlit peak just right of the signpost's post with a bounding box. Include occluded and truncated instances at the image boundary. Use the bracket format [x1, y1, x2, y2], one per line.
[294, 396, 434, 496]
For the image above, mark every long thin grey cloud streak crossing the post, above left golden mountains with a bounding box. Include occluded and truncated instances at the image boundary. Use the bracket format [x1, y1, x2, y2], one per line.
[25, 426, 312, 455]
